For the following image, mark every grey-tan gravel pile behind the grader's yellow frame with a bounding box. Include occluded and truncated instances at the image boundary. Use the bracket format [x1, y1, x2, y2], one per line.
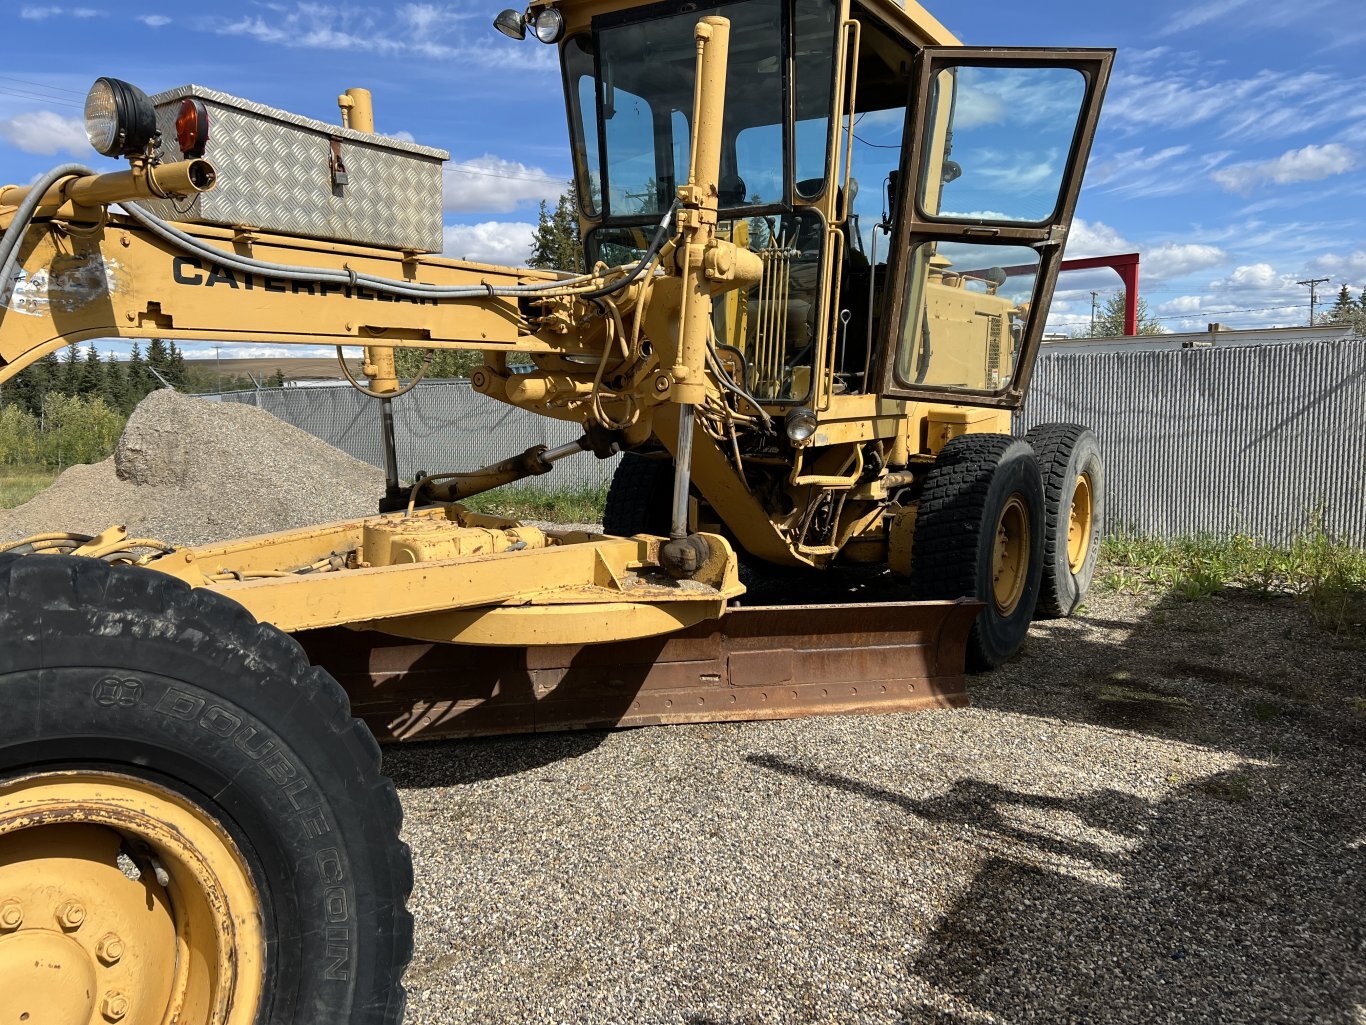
[0, 391, 384, 544]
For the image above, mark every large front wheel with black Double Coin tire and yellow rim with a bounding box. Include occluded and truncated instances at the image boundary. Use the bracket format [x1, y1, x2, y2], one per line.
[0, 555, 413, 1025]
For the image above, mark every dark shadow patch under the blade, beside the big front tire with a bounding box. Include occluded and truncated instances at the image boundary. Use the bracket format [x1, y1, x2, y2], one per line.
[382, 730, 608, 790]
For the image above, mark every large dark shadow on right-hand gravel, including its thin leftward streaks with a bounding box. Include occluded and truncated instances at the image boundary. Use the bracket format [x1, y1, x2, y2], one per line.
[885, 597, 1366, 1025]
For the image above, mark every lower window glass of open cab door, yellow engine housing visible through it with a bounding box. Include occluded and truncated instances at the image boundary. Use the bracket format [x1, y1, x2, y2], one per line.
[896, 242, 1038, 392]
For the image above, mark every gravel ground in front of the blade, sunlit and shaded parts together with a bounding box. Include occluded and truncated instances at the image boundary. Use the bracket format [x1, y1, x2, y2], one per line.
[385, 584, 1366, 1025]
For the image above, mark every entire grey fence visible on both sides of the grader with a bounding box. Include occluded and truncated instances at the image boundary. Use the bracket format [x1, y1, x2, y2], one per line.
[223, 338, 1366, 544]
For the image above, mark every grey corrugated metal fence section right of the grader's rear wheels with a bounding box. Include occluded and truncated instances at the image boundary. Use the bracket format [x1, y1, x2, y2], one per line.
[1022, 338, 1366, 544]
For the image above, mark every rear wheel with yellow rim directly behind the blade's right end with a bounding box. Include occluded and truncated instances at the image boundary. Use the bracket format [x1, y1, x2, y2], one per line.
[911, 435, 1044, 672]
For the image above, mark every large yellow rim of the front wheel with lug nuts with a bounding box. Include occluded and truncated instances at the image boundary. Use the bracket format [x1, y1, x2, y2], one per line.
[0, 771, 265, 1025]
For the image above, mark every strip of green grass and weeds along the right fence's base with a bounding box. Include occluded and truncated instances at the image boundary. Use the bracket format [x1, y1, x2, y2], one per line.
[1097, 525, 1366, 633]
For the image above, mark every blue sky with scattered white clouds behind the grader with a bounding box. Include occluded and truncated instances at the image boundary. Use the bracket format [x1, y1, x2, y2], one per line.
[0, 0, 1366, 358]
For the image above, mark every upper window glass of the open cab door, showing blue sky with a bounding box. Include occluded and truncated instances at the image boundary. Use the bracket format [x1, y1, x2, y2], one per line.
[919, 67, 1086, 224]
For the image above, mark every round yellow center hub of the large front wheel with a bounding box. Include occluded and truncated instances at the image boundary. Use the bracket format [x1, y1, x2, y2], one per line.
[0, 929, 100, 1025]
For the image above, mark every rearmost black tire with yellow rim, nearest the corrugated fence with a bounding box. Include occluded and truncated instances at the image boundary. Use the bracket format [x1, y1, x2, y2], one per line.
[1025, 424, 1105, 619]
